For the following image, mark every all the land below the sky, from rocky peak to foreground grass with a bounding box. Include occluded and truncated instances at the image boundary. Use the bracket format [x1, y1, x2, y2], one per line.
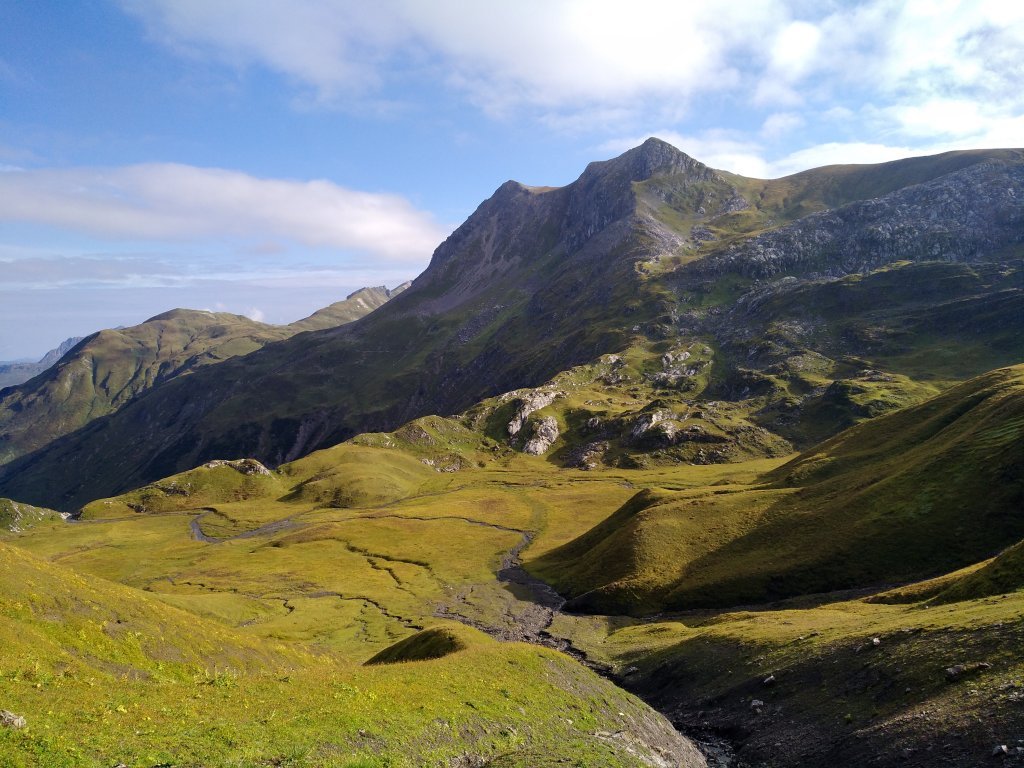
[0, 139, 1024, 768]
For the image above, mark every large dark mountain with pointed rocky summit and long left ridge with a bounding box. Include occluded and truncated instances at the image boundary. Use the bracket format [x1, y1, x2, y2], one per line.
[0, 139, 1024, 509]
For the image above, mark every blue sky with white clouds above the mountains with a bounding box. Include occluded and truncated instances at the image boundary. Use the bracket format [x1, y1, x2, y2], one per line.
[0, 0, 1024, 360]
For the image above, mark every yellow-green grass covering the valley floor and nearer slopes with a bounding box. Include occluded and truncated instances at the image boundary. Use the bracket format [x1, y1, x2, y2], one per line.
[0, 358, 1024, 766]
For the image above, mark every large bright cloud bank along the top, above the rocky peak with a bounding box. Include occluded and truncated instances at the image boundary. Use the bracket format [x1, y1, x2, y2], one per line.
[122, 0, 1024, 175]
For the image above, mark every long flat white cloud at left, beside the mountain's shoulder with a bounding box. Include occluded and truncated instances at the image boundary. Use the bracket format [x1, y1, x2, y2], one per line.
[0, 163, 444, 262]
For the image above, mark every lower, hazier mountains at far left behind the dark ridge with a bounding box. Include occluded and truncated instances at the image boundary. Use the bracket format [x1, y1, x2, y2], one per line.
[0, 284, 408, 464]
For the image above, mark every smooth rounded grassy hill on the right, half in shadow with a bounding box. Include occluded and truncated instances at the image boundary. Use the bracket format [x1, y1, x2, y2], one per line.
[530, 366, 1024, 614]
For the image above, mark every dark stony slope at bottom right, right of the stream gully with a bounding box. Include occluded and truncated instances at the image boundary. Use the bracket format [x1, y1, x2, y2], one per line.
[551, 569, 1024, 768]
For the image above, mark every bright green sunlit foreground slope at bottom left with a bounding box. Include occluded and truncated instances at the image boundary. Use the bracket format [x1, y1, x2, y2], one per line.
[0, 544, 702, 768]
